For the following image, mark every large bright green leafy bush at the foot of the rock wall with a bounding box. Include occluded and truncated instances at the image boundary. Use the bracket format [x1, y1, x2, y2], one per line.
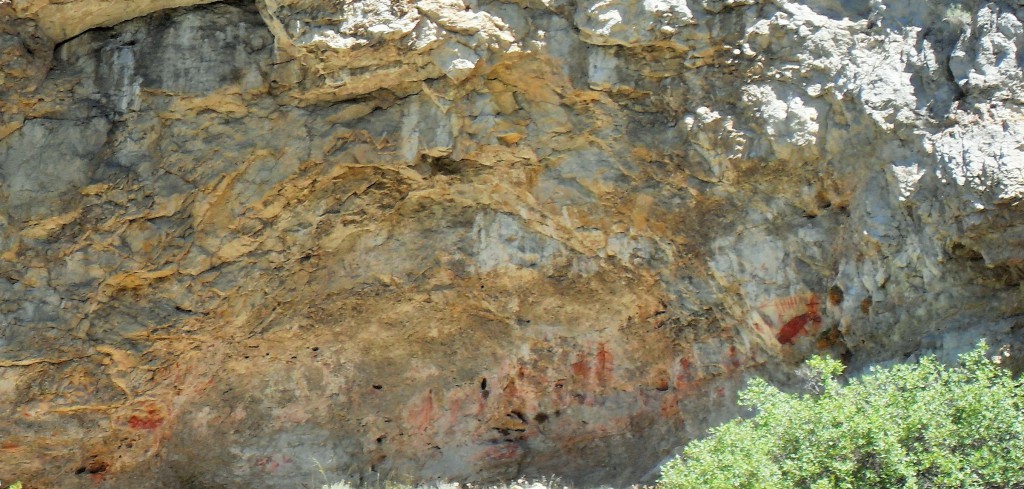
[660, 343, 1024, 489]
